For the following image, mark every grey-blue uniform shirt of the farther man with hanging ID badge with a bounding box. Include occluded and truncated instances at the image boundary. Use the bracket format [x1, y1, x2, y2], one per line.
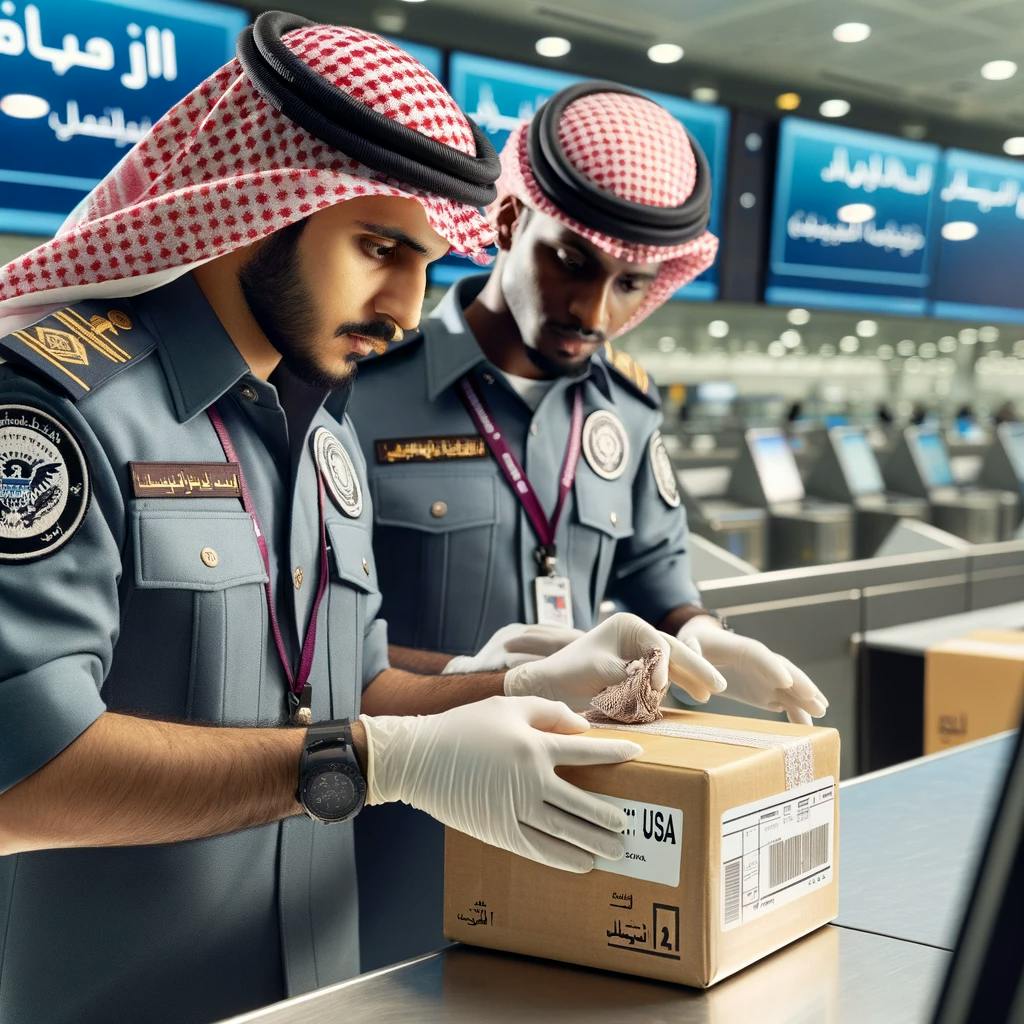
[346, 276, 699, 654]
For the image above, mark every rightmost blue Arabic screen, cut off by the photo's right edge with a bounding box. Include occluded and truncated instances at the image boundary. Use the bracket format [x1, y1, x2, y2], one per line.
[932, 150, 1024, 324]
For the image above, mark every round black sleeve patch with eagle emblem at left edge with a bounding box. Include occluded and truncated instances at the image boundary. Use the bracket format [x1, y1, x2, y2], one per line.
[0, 406, 90, 562]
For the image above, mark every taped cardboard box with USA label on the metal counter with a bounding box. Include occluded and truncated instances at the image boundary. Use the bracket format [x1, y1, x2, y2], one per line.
[444, 711, 840, 987]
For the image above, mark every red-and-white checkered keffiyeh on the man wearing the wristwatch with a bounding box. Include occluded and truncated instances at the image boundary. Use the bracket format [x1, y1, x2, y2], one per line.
[0, 25, 495, 335]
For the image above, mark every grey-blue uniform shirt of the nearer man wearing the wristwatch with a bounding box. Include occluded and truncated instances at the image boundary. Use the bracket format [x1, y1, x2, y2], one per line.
[0, 278, 387, 1024]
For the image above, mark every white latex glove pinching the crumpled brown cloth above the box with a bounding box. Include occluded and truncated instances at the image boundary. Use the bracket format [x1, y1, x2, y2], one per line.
[505, 612, 725, 711]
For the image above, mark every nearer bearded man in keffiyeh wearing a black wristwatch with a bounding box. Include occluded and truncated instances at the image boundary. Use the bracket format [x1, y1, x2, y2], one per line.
[0, 12, 714, 1024]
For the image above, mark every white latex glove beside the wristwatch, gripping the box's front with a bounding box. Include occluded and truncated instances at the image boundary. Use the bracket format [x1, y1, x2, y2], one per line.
[360, 697, 642, 873]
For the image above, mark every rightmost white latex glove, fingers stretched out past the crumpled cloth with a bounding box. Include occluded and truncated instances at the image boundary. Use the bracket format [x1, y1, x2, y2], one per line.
[679, 615, 828, 725]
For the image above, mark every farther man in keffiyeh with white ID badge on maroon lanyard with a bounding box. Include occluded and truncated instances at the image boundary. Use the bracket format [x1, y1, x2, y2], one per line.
[344, 82, 827, 967]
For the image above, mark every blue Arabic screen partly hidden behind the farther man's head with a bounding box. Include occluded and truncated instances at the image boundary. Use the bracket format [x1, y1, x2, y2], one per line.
[431, 53, 729, 300]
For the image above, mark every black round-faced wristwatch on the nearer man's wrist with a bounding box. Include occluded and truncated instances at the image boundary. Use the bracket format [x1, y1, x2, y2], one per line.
[295, 718, 367, 823]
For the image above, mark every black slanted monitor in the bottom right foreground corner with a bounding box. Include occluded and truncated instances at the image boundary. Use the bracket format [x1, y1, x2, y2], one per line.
[933, 730, 1024, 1024]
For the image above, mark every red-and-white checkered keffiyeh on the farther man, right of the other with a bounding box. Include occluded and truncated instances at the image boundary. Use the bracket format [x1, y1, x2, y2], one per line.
[487, 92, 718, 334]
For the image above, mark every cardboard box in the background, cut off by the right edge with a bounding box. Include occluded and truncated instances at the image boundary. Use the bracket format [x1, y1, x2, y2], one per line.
[925, 630, 1024, 754]
